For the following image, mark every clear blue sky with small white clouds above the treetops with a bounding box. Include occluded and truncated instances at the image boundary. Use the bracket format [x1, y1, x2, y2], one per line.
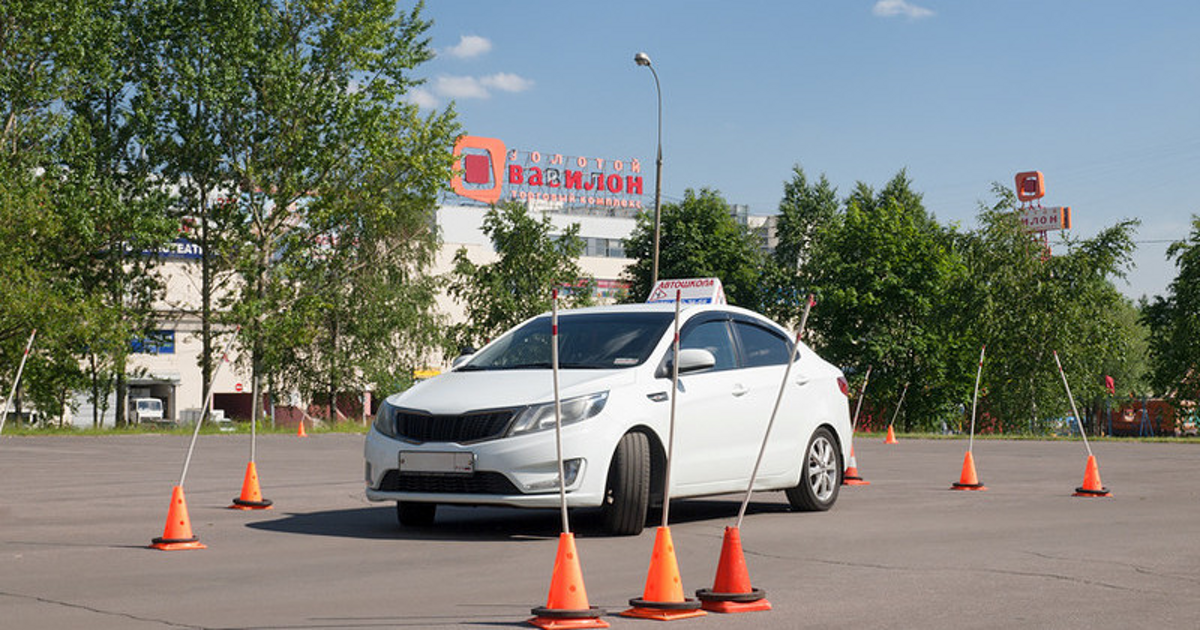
[413, 0, 1200, 299]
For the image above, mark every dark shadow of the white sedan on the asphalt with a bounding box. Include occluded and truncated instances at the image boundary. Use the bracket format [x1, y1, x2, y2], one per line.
[246, 497, 791, 541]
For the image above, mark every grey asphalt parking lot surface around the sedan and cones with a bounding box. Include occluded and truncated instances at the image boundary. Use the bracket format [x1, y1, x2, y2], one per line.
[0, 434, 1200, 630]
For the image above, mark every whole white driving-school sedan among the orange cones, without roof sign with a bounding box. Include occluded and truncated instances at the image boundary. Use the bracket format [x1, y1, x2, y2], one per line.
[365, 304, 851, 535]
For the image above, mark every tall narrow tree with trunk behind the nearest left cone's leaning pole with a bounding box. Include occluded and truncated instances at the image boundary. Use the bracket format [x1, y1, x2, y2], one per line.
[136, 0, 264, 407]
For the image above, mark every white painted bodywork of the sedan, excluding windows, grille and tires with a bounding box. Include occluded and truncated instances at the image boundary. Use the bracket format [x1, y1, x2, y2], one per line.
[365, 305, 851, 508]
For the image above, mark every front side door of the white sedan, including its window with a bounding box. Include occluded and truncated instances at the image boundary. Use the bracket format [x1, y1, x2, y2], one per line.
[666, 313, 761, 496]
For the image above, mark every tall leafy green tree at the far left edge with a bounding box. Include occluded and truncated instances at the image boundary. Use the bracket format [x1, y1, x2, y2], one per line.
[0, 1, 175, 422]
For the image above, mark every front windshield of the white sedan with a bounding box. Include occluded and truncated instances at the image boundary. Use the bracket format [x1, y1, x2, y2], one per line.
[460, 312, 673, 371]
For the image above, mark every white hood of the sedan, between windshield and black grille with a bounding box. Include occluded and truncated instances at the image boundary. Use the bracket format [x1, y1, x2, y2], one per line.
[388, 368, 637, 414]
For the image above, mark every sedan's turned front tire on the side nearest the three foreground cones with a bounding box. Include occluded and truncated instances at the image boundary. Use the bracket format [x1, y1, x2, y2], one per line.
[600, 433, 650, 536]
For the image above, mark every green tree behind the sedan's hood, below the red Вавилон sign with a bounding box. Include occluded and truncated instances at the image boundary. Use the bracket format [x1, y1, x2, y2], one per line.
[446, 202, 593, 353]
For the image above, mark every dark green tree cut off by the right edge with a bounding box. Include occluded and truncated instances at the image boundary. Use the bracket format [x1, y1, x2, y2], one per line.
[1141, 215, 1200, 401]
